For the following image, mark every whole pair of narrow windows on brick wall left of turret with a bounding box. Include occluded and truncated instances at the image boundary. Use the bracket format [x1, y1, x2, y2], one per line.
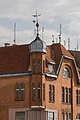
[15, 82, 25, 101]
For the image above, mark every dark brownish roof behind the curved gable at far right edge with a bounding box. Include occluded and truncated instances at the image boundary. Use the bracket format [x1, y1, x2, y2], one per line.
[69, 50, 80, 70]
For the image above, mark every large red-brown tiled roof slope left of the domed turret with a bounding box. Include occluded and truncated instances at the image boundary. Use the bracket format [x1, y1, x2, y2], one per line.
[0, 45, 29, 74]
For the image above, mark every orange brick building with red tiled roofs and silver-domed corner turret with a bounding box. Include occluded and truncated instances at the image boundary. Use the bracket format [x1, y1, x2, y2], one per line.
[0, 30, 80, 120]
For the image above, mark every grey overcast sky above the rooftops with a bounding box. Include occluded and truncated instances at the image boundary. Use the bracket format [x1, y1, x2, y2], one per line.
[0, 0, 80, 50]
